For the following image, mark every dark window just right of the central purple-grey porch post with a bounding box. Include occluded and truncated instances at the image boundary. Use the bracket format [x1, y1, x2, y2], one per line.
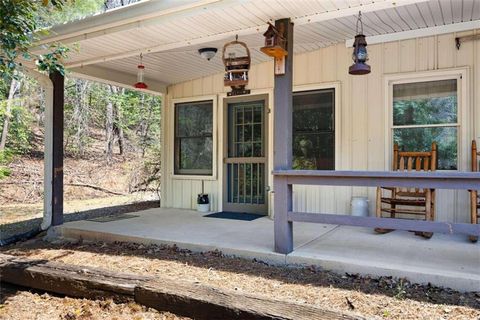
[293, 89, 335, 170]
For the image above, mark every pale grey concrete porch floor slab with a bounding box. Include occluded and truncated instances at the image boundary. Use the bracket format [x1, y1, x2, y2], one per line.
[51, 208, 480, 291]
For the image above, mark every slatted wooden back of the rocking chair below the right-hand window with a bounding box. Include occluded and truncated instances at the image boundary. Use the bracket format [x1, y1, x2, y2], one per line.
[392, 142, 436, 197]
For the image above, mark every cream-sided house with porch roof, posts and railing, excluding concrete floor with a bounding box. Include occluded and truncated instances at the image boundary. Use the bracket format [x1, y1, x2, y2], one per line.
[27, 0, 480, 290]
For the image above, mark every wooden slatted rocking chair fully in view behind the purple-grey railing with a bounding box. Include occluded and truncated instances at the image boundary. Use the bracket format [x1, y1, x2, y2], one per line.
[375, 142, 437, 238]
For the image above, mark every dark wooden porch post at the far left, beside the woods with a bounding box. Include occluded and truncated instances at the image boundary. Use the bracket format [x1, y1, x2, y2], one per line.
[45, 71, 65, 226]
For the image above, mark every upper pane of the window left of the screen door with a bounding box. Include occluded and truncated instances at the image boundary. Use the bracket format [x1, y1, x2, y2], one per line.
[175, 101, 213, 137]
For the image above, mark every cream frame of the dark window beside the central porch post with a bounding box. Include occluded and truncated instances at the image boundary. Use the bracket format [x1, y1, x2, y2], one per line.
[292, 81, 342, 170]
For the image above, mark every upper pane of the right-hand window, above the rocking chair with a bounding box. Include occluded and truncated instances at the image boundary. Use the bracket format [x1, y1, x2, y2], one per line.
[393, 79, 457, 126]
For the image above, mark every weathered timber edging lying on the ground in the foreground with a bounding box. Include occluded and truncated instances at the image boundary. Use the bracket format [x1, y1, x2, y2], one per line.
[0, 254, 364, 320]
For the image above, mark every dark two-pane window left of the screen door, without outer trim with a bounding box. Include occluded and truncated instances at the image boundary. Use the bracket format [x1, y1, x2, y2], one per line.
[174, 101, 213, 175]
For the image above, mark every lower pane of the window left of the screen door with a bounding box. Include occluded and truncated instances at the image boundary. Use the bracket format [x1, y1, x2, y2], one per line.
[178, 137, 213, 174]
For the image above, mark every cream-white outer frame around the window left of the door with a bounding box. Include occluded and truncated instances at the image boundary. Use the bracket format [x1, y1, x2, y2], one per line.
[170, 95, 218, 180]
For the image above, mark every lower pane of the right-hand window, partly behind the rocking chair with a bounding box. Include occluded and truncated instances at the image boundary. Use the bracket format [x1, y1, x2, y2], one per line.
[393, 127, 457, 170]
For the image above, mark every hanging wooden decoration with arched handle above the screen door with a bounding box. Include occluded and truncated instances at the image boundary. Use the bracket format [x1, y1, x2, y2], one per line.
[222, 40, 251, 95]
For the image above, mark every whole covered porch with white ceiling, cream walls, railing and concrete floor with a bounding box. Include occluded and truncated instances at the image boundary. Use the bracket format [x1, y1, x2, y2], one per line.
[31, 0, 480, 290]
